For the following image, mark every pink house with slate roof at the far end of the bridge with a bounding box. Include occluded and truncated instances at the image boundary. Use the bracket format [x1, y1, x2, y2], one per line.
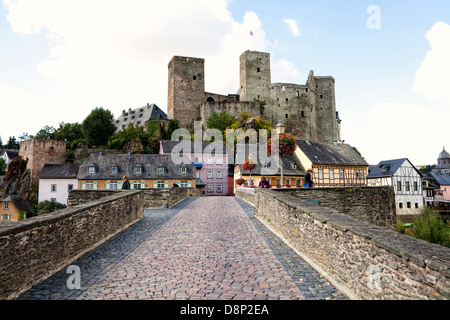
[159, 140, 229, 196]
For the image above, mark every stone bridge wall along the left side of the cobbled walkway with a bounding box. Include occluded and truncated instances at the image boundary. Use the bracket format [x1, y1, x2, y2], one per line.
[0, 188, 202, 300]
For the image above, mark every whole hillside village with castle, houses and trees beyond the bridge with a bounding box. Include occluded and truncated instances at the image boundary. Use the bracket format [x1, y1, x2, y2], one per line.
[0, 51, 450, 230]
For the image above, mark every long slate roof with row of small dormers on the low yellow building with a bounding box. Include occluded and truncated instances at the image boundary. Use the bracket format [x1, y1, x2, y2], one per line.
[77, 154, 196, 180]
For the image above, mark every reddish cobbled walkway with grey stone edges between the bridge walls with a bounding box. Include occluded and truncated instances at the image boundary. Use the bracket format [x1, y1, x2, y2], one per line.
[19, 197, 346, 300]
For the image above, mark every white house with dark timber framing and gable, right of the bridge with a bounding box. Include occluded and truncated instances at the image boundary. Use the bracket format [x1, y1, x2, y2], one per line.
[367, 158, 424, 215]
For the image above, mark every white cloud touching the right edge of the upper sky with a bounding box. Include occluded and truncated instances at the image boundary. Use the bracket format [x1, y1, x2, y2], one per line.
[412, 22, 450, 103]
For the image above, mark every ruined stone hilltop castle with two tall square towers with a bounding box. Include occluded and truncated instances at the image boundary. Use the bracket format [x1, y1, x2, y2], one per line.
[167, 51, 340, 143]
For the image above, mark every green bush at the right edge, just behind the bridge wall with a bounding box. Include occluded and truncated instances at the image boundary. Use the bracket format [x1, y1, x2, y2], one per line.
[414, 207, 450, 247]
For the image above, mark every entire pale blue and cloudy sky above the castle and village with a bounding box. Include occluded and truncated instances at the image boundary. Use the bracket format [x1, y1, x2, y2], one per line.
[0, 0, 450, 165]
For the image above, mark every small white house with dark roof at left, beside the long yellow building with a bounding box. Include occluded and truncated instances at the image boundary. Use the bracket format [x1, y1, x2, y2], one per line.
[38, 164, 78, 205]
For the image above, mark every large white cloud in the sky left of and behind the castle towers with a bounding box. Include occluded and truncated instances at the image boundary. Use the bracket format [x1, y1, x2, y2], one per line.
[0, 0, 270, 139]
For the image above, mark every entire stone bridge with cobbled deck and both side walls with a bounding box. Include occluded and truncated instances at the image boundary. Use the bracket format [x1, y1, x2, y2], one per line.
[0, 188, 450, 300]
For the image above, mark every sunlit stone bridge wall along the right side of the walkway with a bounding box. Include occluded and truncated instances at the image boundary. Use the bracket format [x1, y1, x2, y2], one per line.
[250, 189, 450, 300]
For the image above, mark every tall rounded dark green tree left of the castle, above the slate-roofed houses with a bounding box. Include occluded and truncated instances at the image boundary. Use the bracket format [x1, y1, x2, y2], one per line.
[81, 107, 116, 147]
